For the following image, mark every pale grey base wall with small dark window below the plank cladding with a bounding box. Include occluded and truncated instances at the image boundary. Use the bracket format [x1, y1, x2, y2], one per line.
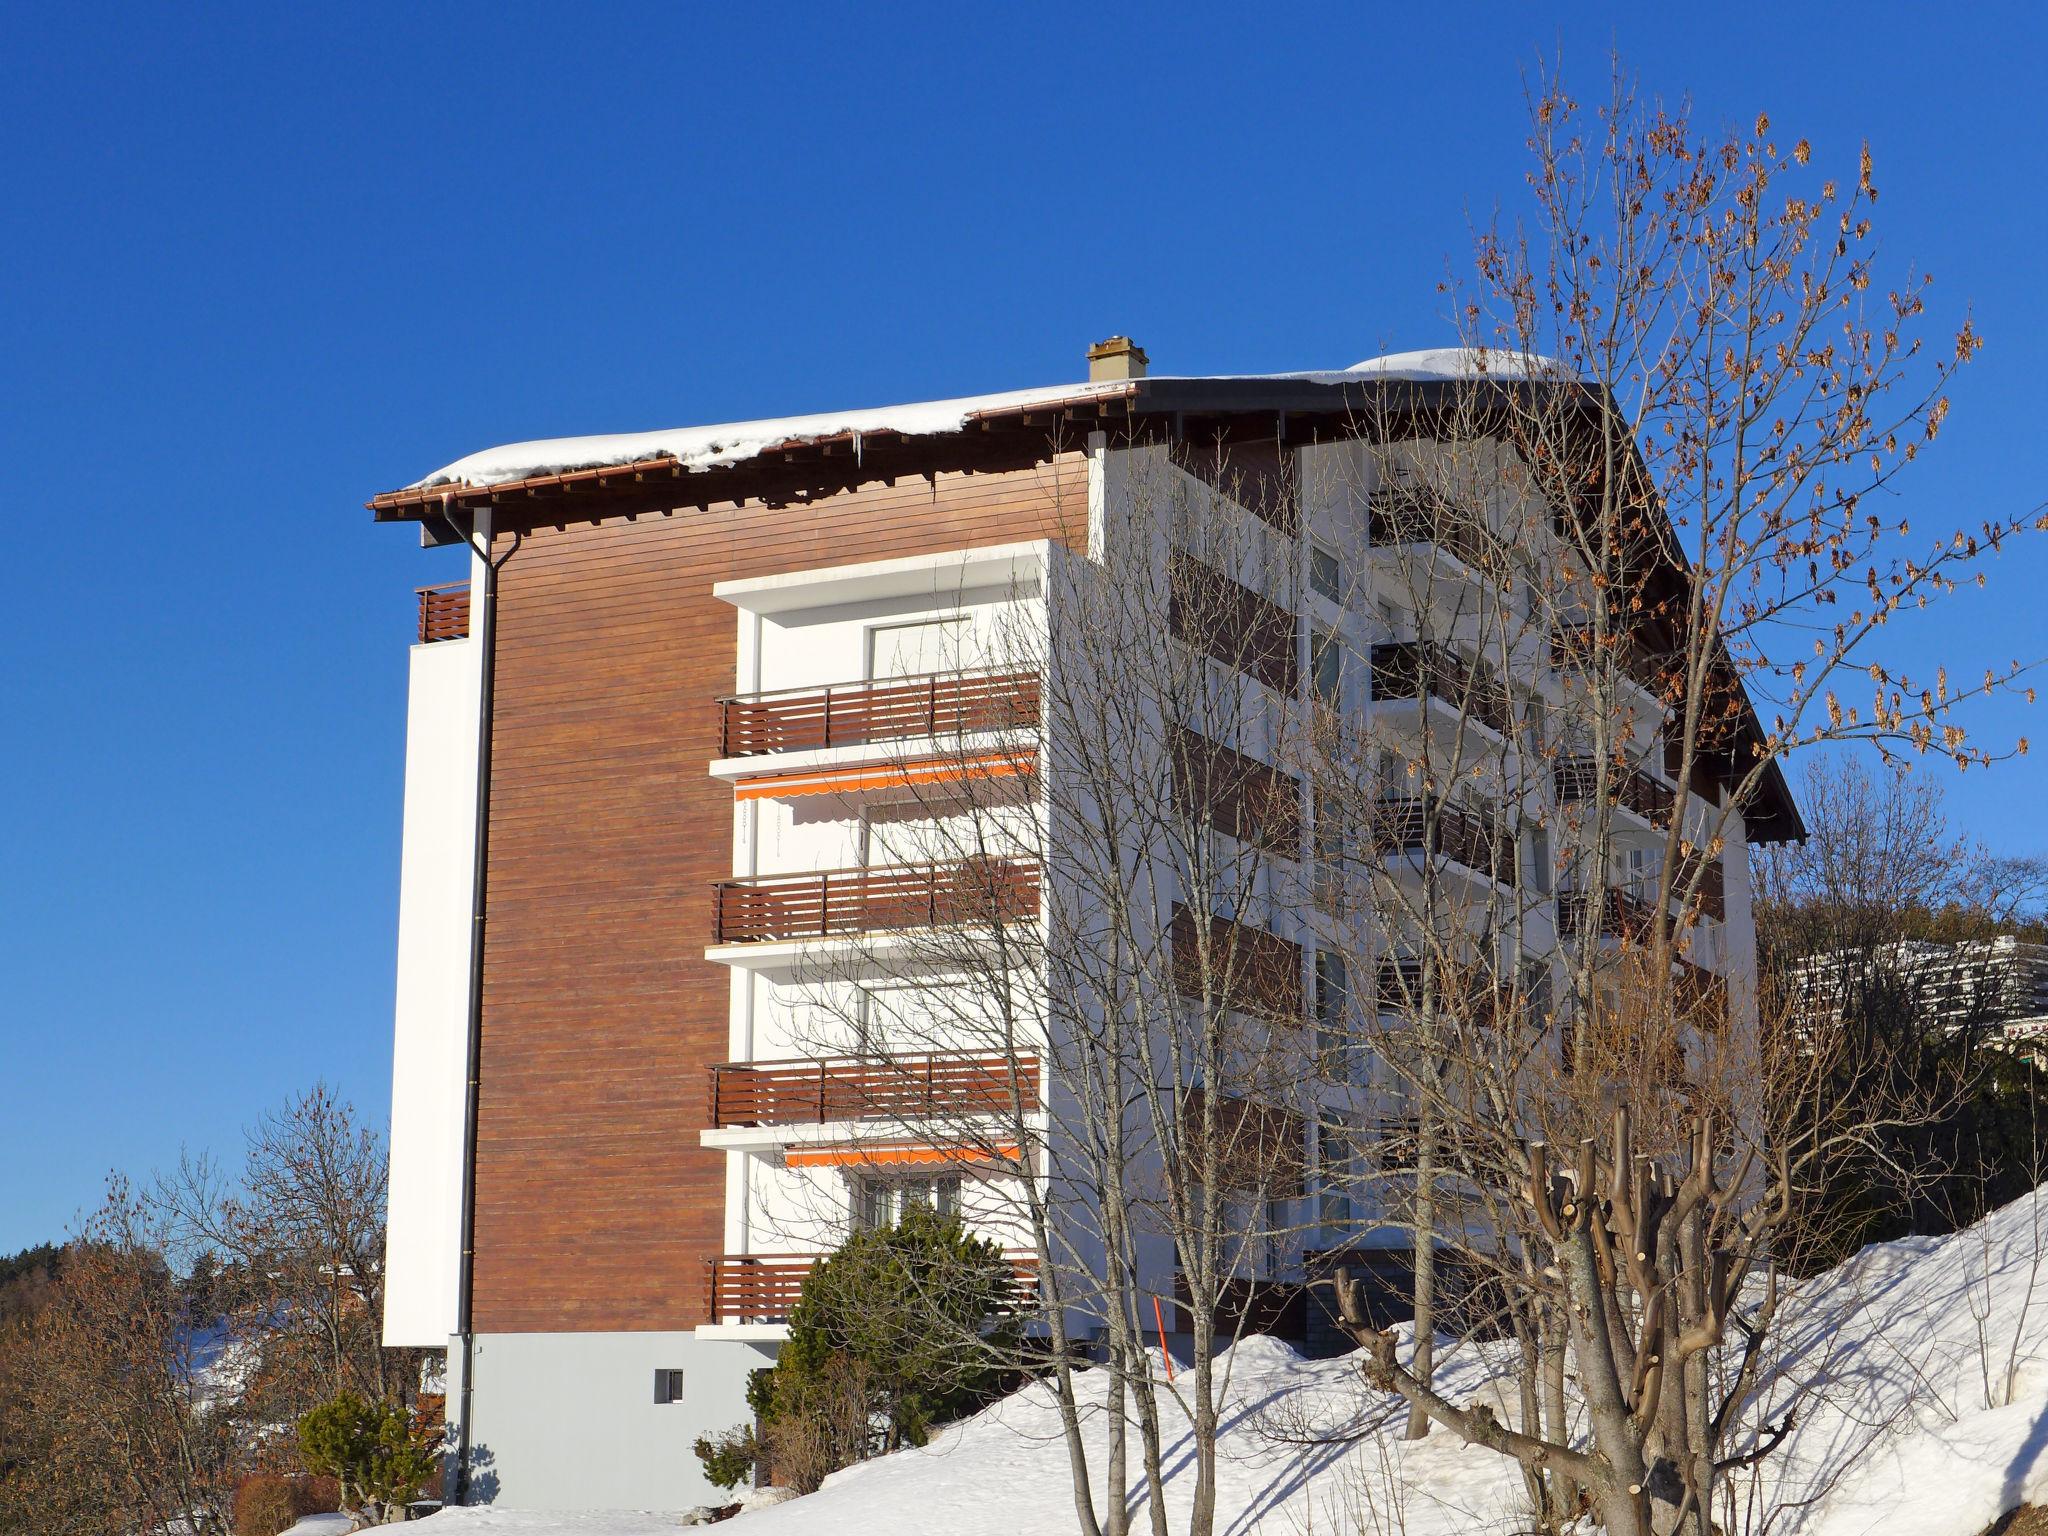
[449, 1333, 774, 1509]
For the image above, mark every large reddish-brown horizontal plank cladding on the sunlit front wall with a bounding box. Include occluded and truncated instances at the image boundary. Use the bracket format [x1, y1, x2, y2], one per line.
[475, 451, 1087, 1333]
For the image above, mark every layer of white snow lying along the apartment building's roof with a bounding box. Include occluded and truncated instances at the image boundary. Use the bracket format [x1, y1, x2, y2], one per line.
[406, 346, 1565, 492]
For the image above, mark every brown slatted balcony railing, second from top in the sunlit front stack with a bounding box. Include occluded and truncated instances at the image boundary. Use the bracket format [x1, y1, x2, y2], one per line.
[713, 858, 1038, 944]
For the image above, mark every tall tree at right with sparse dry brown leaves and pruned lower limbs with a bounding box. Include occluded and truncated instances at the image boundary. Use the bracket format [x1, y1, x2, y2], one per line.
[1269, 54, 2038, 1532]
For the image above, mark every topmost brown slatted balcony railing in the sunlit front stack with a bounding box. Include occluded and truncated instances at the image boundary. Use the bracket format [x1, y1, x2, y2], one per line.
[719, 672, 1038, 758]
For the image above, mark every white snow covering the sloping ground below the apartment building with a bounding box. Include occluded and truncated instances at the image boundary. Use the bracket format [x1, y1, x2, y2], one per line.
[407, 1190, 2048, 1536]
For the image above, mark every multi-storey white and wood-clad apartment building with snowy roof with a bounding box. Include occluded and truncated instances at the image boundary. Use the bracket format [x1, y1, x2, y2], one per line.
[371, 338, 1800, 1507]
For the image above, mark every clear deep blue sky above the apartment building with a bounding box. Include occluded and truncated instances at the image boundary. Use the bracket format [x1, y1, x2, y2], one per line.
[0, 4, 2048, 1251]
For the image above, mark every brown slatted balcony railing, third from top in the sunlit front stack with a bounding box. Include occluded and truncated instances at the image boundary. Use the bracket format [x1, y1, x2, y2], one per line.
[711, 1051, 1038, 1128]
